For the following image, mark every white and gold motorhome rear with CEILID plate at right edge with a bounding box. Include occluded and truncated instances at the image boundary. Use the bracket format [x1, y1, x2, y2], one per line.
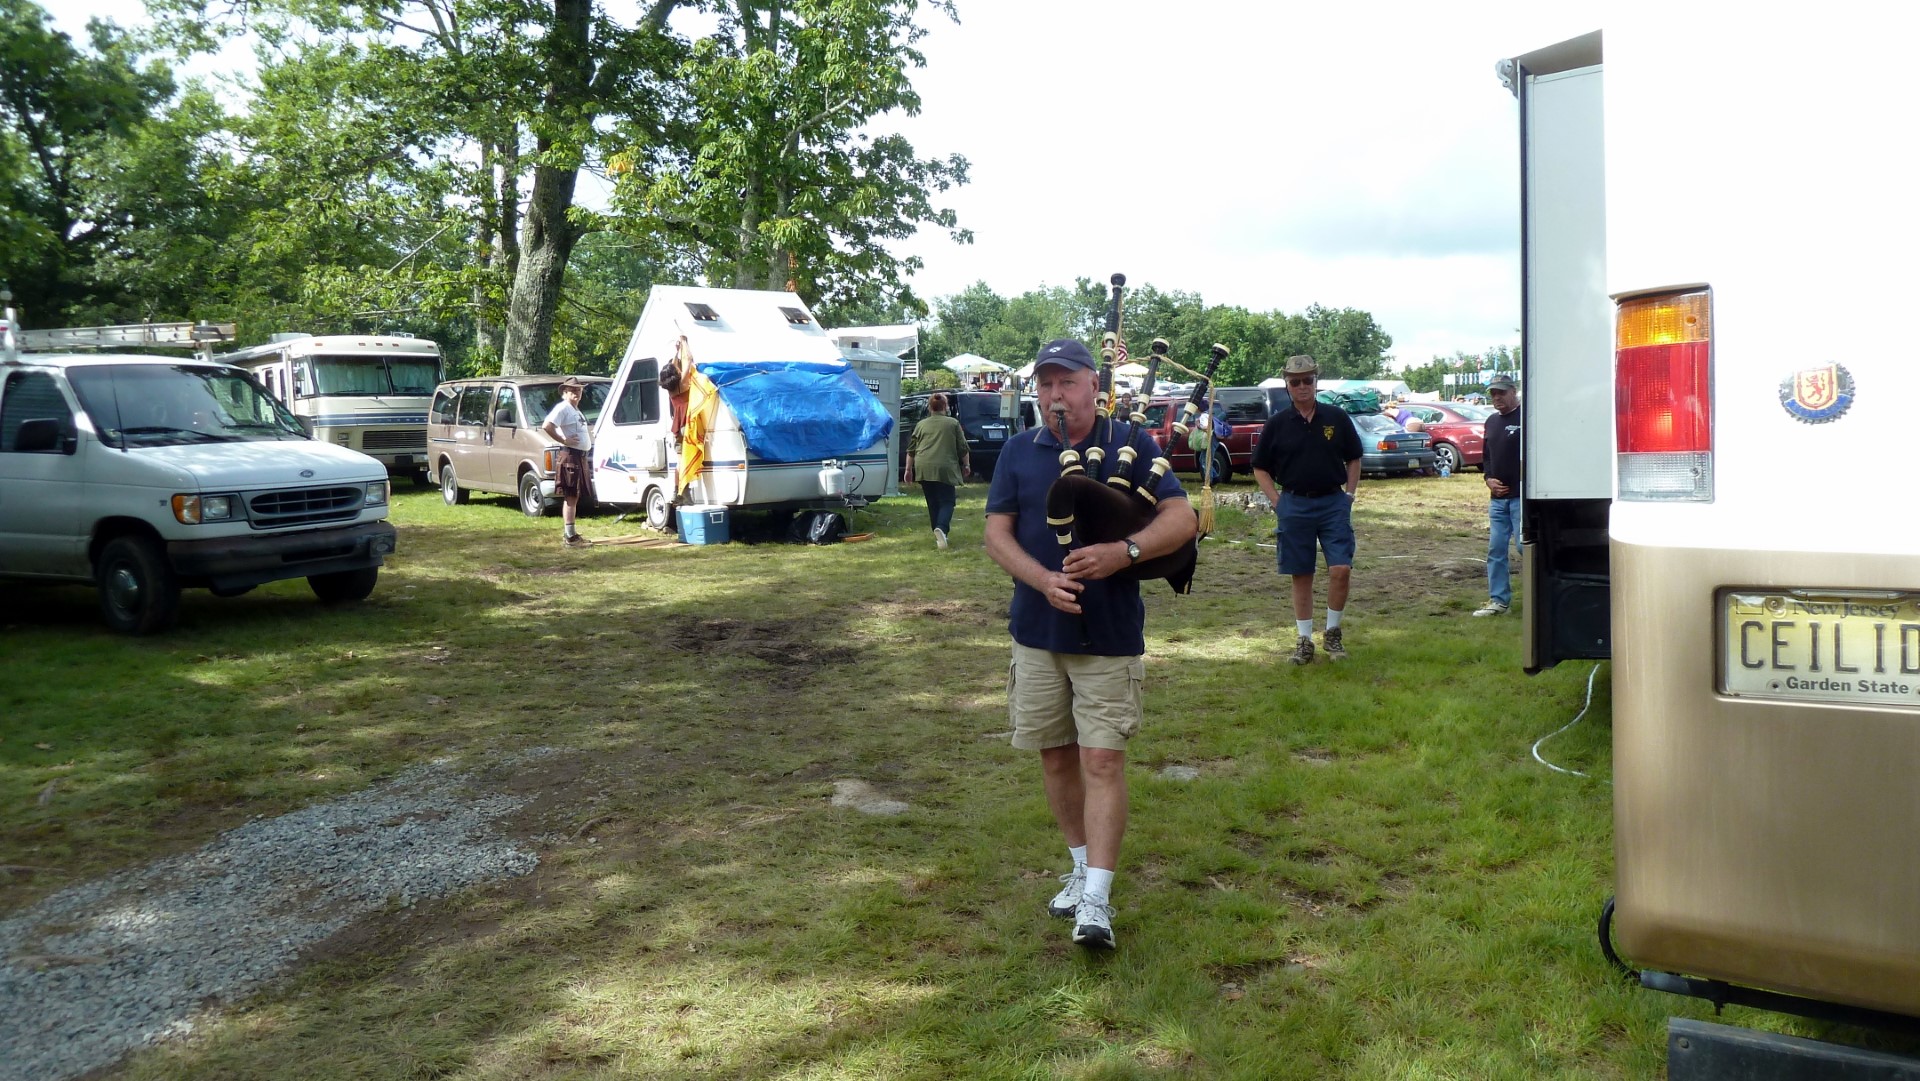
[1501, 14, 1920, 1077]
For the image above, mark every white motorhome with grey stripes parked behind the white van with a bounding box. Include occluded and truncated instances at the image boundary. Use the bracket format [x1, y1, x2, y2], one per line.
[221, 334, 442, 482]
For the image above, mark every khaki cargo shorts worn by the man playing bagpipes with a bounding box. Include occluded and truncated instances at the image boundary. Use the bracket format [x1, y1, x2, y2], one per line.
[1006, 641, 1146, 751]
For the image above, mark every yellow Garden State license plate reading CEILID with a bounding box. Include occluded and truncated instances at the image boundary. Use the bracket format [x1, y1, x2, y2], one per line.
[1720, 589, 1920, 707]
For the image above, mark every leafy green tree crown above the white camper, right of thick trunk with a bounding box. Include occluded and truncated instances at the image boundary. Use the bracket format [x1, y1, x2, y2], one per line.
[611, 0, 972, 320]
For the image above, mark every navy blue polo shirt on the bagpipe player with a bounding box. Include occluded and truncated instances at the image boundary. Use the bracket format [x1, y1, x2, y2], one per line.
[987, 420, 1187, 657]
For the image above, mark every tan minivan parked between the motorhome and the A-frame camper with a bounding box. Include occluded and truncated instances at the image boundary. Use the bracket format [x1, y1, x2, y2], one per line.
[426, 372, 612, 518]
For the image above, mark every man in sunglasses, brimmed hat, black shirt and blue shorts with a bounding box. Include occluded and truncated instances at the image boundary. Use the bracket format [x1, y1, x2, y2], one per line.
[1254, 355, 1361, 664]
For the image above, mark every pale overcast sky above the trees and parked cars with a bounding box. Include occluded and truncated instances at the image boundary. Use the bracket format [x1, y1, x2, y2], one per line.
[50, 0, 1603, 365]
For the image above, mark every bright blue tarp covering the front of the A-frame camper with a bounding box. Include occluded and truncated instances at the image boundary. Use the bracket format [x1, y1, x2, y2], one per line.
[695, 361, 893, 461]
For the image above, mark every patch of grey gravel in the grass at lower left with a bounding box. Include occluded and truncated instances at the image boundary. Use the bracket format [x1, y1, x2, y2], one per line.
[0, 762, 540, 1081]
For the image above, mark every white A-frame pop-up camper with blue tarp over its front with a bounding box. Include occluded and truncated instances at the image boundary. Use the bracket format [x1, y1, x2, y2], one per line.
[593, 286, 893, 530]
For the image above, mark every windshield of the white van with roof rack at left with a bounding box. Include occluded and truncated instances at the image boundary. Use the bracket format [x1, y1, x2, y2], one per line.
[67, 365, 307, 449]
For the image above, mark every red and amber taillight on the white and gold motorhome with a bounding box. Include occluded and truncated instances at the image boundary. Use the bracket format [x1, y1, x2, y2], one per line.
[1613, 290, 1713, 501]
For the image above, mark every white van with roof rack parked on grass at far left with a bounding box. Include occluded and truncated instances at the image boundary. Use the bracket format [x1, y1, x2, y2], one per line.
[0, 313, 394, 634]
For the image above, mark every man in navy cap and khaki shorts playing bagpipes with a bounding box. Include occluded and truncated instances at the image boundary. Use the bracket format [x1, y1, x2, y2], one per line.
[987, 338, 1194, 949]
